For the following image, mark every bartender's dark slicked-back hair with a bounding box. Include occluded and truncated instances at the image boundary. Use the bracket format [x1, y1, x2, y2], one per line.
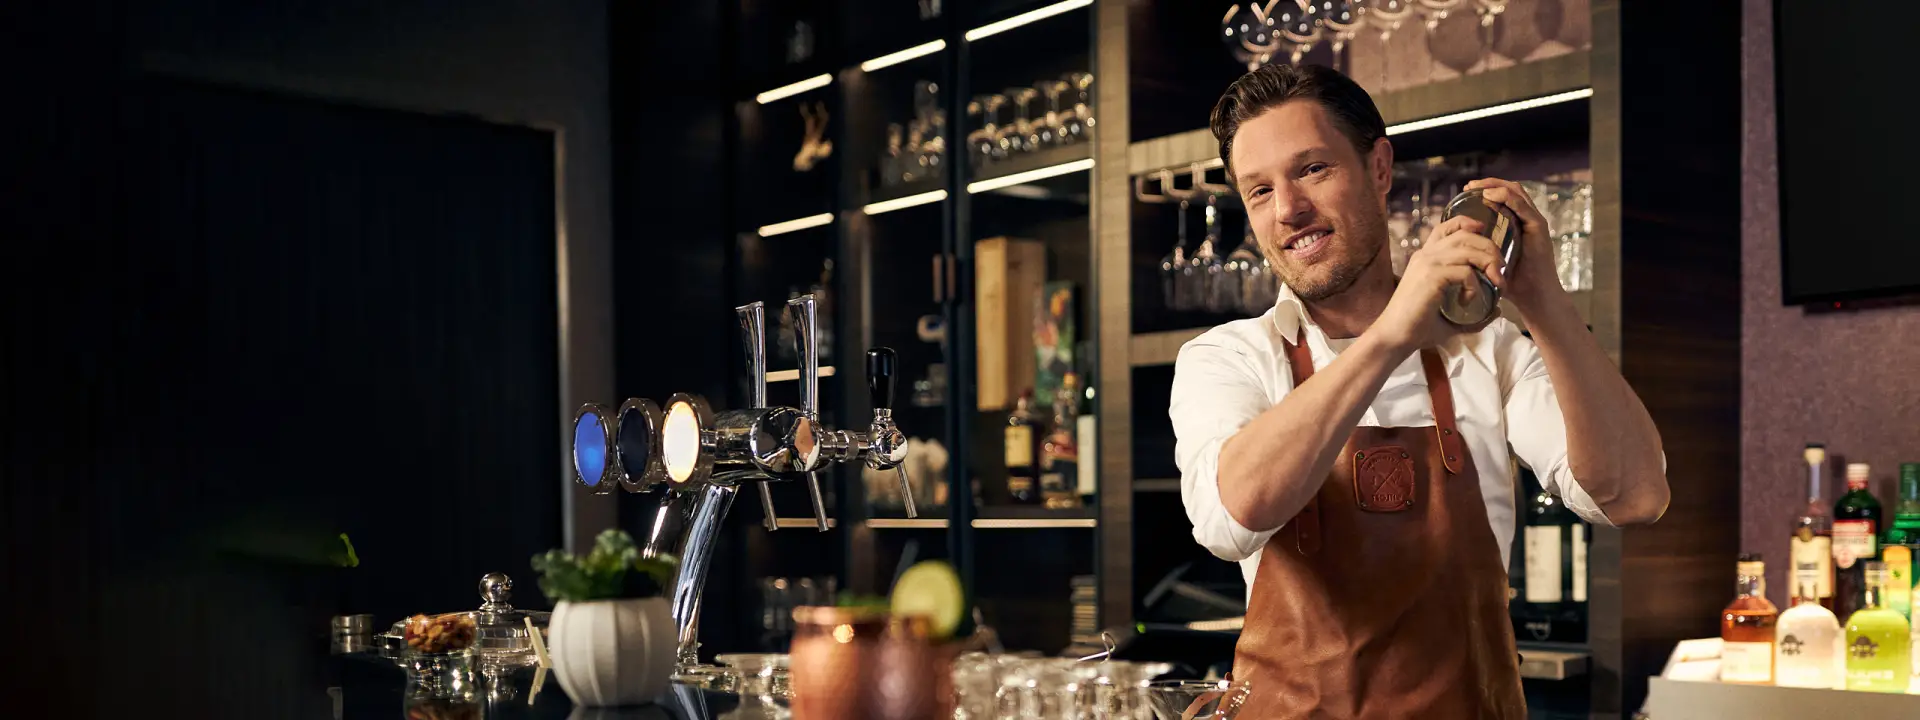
[1212, 65, 1386, 180]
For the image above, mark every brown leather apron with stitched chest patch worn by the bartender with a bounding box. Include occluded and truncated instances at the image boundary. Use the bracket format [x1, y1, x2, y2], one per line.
[1233, 342, 1526, 720]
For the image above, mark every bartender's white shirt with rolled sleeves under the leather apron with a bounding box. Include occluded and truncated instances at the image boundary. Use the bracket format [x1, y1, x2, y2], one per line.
[1167, 286, 1613, 593]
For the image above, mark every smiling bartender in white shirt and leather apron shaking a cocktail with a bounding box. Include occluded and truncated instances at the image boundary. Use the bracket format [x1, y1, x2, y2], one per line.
[1169, 65, 1668, 718]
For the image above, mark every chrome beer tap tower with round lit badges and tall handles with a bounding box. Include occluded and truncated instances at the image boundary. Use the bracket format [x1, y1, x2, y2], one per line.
[572, 296, 918, 668]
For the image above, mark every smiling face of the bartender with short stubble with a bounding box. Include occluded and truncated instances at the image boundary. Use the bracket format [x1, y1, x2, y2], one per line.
[1231, 100, 1392, 301]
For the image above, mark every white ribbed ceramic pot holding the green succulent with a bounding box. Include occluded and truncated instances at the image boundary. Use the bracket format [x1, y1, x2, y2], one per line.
[547, 597, 678, 707]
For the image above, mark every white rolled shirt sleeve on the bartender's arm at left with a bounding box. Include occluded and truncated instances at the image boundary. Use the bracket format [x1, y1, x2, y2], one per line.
[1167, 336, 1281, 563]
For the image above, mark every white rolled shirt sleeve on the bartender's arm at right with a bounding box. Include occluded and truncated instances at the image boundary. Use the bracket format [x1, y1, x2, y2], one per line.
[1496, 323, 1628, 526]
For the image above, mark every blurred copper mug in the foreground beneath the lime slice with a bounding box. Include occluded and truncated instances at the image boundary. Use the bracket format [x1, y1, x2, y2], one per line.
[789, 607, 956, 720]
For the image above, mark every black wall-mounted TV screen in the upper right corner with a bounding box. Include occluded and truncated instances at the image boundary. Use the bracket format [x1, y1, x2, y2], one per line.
[1763, 0, 1920, 305]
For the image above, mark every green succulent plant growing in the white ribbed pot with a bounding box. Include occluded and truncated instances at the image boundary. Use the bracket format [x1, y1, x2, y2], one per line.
[534, 530, 680, 603]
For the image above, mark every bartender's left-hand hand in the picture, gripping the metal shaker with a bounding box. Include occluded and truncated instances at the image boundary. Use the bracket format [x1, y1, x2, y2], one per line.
[1367, 217, 1505, 353]
